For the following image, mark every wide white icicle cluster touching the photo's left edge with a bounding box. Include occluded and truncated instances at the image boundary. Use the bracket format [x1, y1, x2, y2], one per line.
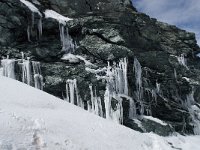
[1, 59, 15, 79]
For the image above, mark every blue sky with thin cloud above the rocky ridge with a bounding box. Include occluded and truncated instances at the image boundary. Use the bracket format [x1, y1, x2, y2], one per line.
[132, 0, 200, 45]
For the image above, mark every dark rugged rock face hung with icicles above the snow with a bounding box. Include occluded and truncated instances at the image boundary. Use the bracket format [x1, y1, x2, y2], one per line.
[0, 0, 200, 134]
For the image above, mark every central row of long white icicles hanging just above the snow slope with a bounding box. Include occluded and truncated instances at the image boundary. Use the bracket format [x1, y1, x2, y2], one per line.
[66, 58, 143, 124]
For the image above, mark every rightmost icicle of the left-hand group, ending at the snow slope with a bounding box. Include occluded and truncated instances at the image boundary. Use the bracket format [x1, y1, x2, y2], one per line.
[32, 61, 43, 90]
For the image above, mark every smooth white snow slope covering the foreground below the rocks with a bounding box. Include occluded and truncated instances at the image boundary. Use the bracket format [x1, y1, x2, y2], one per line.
[0, 77, 200, 150]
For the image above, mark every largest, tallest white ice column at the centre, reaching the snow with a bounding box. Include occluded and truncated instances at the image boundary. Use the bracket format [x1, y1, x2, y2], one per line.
[101, 58, 128, 123]
